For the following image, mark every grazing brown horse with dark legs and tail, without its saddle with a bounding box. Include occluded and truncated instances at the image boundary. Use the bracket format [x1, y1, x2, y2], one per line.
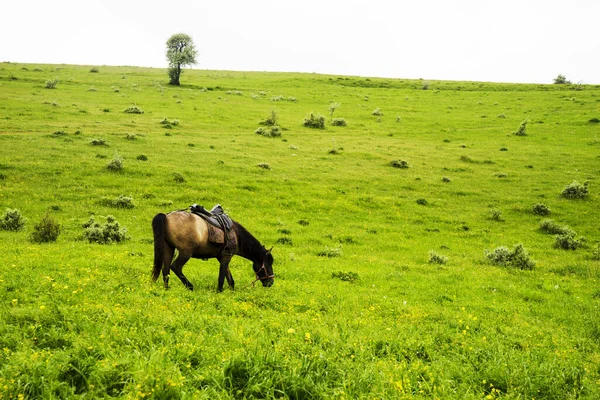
[152, 211, 275, 291]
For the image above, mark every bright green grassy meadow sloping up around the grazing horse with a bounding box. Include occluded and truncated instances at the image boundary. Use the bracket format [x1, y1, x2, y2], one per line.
[0, 63, 600, 399]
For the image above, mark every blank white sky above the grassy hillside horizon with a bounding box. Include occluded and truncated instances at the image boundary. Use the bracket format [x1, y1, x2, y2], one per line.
[0, 0, 600, 84]
